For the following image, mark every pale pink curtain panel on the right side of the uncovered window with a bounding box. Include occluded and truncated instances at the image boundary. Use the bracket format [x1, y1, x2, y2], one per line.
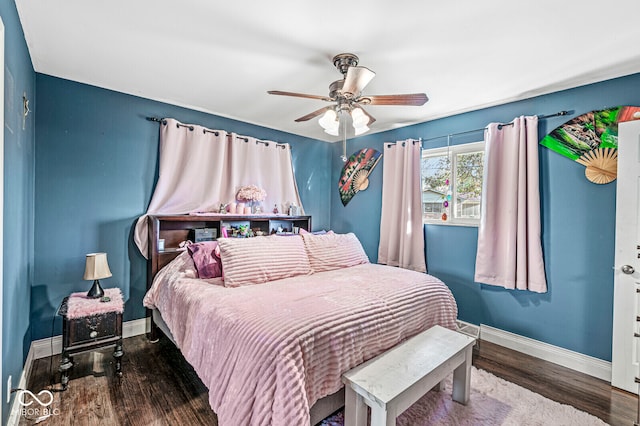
[475, 116, 547, 293]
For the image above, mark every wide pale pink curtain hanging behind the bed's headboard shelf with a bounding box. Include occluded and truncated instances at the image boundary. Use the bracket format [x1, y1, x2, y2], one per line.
[134, 119, 304, 258]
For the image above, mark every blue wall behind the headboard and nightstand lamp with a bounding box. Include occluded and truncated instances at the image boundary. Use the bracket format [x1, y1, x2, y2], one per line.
[31, 74, 331, 340]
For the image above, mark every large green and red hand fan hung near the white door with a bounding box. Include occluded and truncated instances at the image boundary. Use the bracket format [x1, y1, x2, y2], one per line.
[540, 106, 640, 184]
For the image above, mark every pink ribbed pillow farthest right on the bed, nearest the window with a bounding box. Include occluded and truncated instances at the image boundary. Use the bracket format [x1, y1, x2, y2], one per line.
[302, 231, 369, 272]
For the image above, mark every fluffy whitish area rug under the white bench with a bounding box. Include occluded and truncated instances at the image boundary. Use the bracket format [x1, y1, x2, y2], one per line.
[321, 367, 607, 426]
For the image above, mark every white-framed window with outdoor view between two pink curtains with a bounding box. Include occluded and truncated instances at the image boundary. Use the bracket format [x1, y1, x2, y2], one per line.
[422, 142, 484, 226]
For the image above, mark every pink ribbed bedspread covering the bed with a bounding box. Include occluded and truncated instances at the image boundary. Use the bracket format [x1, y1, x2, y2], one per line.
[144, 254, 457, 426]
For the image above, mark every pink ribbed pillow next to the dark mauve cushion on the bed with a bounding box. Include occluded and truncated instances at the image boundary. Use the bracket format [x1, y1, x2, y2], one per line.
[218, 236, 312, 287]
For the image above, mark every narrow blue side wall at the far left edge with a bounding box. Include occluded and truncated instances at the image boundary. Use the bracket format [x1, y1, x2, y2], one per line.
[0, 1, 35, 424]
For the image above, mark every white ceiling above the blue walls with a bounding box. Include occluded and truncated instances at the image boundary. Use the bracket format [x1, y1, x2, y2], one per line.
[16, 0, 640, 141]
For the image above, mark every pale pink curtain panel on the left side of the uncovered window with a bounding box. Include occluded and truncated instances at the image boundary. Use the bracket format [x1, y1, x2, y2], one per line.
[378, 139, 427, 272]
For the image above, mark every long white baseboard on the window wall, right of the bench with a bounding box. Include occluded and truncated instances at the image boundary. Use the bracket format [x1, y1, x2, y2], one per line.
[480, 324, 611, 383]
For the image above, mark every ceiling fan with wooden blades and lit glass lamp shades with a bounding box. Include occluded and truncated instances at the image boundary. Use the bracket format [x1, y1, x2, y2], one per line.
[267, 53, 429, 138]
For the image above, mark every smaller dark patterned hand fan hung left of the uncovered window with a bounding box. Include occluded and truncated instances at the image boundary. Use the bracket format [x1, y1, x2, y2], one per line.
[338, 148, 382, 206]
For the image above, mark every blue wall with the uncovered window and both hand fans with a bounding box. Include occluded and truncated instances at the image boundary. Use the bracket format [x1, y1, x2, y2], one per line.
[331, 74, 640, 361]
